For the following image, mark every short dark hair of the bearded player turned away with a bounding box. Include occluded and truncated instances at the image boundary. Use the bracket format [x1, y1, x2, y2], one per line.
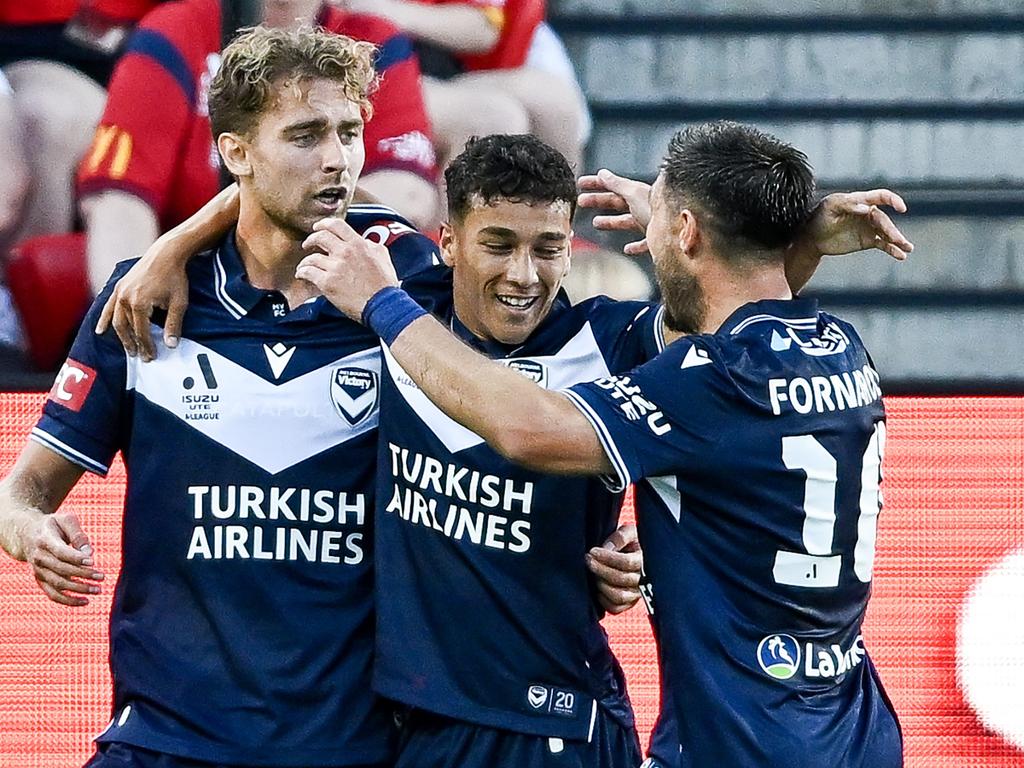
[662, 121, 814, 256]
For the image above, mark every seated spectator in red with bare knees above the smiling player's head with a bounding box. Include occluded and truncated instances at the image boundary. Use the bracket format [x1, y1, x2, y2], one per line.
[342, 0, 590, 167]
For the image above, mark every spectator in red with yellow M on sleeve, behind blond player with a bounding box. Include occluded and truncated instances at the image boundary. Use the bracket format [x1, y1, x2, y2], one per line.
[79, 0, 437, 291]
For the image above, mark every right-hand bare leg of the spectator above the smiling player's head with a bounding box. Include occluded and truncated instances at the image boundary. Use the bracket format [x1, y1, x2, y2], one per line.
[458, 68, 584, 172]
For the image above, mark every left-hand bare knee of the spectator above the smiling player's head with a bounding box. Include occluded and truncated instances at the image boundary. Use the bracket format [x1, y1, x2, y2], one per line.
[423, 76, 530, 167]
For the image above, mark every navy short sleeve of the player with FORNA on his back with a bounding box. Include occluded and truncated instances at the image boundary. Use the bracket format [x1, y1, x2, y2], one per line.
[563, 337, 729, 490]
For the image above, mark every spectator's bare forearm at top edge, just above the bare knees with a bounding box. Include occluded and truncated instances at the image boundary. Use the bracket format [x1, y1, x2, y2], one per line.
[373, 0, 500, 53]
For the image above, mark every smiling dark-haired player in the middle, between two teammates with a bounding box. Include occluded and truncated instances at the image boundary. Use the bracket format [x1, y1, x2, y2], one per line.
[364, 135, 662, 768]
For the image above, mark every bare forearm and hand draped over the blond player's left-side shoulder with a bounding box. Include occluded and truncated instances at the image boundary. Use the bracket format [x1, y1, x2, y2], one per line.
[96, 184, 239, 361]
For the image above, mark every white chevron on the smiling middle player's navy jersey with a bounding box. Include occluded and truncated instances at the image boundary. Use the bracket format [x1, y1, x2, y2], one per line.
[383, 323, 610, 454]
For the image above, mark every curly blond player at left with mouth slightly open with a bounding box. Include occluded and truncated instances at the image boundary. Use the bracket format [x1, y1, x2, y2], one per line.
[0, 29, 436, 768]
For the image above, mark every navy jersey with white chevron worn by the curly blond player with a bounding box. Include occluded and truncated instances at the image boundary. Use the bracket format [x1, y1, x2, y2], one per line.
[33, 207, 436, 767]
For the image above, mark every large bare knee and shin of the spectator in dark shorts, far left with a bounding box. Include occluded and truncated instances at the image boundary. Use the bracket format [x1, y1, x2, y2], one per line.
[5, 61, 106, 239]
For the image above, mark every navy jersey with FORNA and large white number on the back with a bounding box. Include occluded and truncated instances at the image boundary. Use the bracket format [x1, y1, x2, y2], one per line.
[567, 300, 902, 768]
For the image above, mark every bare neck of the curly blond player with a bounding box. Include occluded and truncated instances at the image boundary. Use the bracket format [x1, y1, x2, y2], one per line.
[236, 201, 319, 308]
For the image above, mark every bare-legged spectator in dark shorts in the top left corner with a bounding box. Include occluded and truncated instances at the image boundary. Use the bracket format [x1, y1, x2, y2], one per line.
[0, 0, 157, 247]
